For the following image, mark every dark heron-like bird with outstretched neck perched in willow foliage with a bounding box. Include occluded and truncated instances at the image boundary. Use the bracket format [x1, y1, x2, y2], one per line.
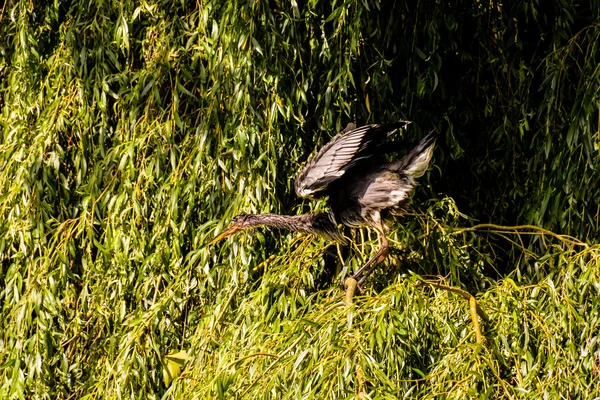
[209, 121, 437, 291]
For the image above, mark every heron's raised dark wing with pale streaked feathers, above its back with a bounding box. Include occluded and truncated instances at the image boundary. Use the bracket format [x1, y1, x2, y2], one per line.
[294, 121, 410, 197]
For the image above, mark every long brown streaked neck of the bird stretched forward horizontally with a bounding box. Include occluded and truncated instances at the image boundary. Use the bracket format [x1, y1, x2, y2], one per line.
[246, 213, 344, 242]
